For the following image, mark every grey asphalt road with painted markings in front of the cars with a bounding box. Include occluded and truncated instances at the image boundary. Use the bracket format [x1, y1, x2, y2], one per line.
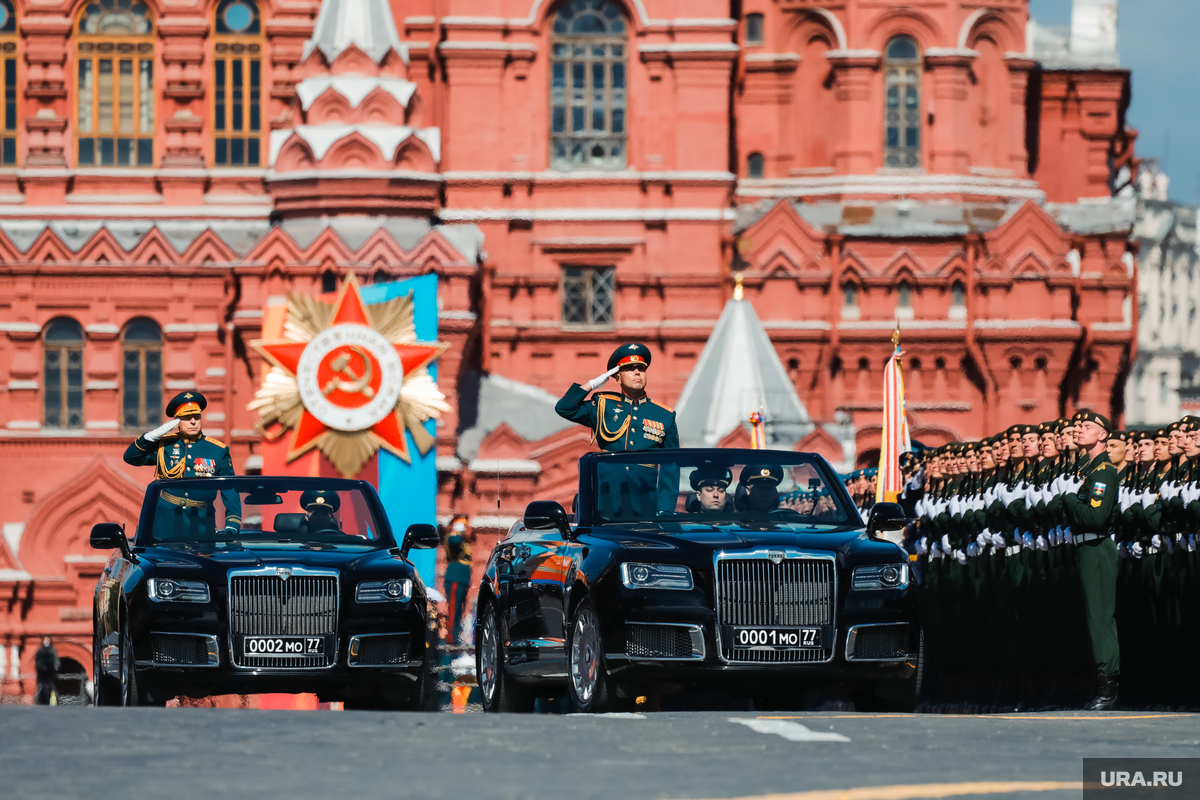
[0, 706, 1200, 800]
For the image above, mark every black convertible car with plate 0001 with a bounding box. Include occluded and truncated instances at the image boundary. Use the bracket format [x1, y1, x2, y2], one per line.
[475, 450, 922, 711]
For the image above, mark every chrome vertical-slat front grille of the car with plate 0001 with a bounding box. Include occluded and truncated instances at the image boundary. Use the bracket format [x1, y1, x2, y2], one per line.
[716, 558, 835, 663]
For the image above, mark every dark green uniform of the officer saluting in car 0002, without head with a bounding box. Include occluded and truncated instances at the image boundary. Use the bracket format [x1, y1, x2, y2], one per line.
[125, 433, 241, 541]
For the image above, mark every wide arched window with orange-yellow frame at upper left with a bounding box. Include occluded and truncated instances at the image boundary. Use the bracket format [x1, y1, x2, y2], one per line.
[76, 0, 155, 167]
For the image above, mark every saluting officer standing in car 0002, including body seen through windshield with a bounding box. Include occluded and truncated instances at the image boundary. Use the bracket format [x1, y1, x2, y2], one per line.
[125, 391, 241, 541]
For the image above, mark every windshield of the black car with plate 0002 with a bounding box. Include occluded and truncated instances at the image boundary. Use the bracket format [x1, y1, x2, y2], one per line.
[138, 477, 391, 547]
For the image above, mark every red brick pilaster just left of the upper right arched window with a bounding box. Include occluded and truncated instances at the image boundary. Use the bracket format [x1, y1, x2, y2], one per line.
[826, 50, 883, 175]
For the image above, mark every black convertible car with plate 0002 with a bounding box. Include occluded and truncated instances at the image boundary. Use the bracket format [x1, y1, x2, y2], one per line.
[91, 477, 438, 709]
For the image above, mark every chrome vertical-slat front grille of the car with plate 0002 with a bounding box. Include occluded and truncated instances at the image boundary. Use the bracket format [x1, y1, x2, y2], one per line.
[229, 575, 337, 669]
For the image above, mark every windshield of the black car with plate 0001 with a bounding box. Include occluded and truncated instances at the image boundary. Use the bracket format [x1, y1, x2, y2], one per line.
[592, 450, 862, 528]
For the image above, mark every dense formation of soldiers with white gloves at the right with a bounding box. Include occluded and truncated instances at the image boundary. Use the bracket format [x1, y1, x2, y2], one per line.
[914, 410, 1200, 710]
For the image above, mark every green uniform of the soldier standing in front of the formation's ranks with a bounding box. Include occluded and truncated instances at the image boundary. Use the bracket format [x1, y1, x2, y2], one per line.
[1063, 413, 1121, 684]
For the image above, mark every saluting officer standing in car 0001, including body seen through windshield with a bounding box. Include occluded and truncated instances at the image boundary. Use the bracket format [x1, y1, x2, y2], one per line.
[554, 342, 679, 518]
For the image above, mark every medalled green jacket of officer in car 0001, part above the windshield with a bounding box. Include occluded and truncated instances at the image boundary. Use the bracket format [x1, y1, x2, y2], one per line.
[554, 384, 679, 452]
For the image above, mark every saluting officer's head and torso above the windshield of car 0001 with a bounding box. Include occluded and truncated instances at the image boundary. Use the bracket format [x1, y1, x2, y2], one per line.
[554, 342, 679, 451]
